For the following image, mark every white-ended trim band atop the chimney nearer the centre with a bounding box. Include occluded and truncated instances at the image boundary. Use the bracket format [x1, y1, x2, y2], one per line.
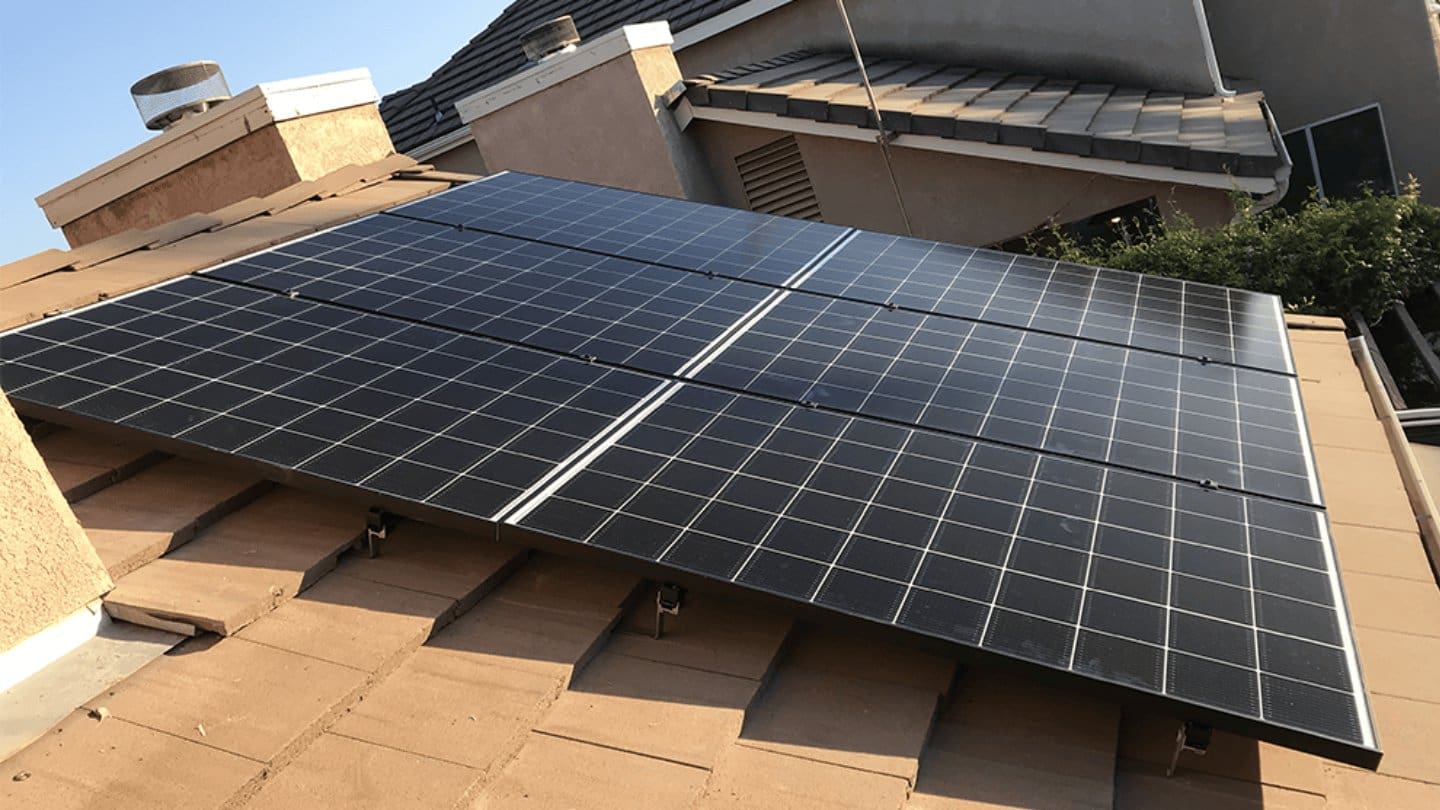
[455, 22, 674, 125]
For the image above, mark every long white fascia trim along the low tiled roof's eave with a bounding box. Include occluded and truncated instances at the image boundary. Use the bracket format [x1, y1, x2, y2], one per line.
[677, 99, 1277, 195]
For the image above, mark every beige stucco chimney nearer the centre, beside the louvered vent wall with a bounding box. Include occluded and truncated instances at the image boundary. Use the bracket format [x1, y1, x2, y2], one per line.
[455, 22, 711, 199]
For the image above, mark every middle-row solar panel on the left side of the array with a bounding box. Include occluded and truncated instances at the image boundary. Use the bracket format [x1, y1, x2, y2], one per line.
[209, 216, 770, 373]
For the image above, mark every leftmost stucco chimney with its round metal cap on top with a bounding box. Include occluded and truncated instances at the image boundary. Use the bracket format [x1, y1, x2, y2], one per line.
[35, 62, 395, 248]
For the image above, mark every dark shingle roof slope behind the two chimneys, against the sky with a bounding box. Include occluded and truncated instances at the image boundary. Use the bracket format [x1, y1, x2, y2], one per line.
[380, 0, 744, 153]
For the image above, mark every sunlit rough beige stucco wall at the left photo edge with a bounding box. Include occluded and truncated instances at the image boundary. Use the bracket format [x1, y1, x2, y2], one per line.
[0, 393, 111, 651]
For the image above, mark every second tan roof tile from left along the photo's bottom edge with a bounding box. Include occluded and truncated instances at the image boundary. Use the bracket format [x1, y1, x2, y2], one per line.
[246, 734, 478, 810]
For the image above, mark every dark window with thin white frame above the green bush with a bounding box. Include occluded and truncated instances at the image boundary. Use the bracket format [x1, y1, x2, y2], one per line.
[1282, 104, 1400, 210]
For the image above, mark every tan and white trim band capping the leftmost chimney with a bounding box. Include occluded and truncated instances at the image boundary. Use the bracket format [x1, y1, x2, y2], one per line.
[35, 68, 380, 228]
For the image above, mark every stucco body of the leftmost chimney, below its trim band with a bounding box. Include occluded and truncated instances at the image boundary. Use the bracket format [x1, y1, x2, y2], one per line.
[63, 104, 393, 248]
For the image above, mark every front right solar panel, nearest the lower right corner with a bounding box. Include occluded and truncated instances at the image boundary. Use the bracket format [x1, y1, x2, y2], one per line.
[521, 386, 1361, 739]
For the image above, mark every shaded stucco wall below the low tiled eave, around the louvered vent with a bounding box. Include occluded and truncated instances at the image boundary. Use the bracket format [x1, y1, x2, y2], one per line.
[687, 121, 1233, 245]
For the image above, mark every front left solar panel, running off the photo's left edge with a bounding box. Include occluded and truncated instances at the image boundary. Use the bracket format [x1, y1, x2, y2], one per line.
[0, 278, 657, 517]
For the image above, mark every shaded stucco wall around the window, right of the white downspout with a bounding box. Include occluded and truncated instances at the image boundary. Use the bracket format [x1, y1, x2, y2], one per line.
[1205, 0, 1440, 196]
